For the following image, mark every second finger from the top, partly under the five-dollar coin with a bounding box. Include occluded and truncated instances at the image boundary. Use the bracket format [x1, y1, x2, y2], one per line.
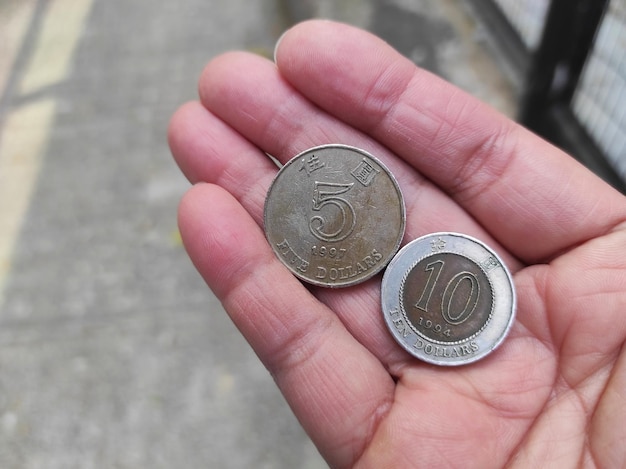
[199, 53, 519, 268]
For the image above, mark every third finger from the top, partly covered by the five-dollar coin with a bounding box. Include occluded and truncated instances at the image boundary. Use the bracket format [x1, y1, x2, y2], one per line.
[169, 96, 407, 370]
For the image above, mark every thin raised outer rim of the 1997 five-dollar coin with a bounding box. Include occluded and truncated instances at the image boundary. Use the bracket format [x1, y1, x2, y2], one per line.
[263, 143, 406, 288]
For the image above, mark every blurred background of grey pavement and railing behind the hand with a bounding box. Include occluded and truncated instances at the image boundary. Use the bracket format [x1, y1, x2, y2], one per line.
[0, 0, 626, 469]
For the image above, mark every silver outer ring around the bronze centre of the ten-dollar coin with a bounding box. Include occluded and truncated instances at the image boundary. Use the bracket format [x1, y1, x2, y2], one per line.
[381, 232, 517, 366]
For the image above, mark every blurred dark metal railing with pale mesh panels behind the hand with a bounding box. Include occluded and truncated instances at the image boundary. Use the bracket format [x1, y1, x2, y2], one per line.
[470, 0, 626, 193]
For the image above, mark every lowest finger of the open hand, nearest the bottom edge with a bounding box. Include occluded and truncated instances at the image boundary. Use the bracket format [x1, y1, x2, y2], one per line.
[179, 184, 394, 466]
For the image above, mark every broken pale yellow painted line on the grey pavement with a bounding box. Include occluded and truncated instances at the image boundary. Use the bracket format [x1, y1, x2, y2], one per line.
[0, 0, 93, 305]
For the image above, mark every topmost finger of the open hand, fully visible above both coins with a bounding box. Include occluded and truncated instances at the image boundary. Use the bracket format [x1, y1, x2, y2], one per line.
[276, 21, 626, 262]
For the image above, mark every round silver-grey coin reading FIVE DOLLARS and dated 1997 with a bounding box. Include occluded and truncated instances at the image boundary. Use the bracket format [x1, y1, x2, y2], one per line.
[264, 145, 406, 287]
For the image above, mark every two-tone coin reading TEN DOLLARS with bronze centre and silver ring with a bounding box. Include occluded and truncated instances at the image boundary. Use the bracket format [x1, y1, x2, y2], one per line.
[381, 233, 516, 366]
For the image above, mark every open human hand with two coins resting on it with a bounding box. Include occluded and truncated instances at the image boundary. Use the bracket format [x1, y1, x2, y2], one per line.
[169, 21, 626, 468]
